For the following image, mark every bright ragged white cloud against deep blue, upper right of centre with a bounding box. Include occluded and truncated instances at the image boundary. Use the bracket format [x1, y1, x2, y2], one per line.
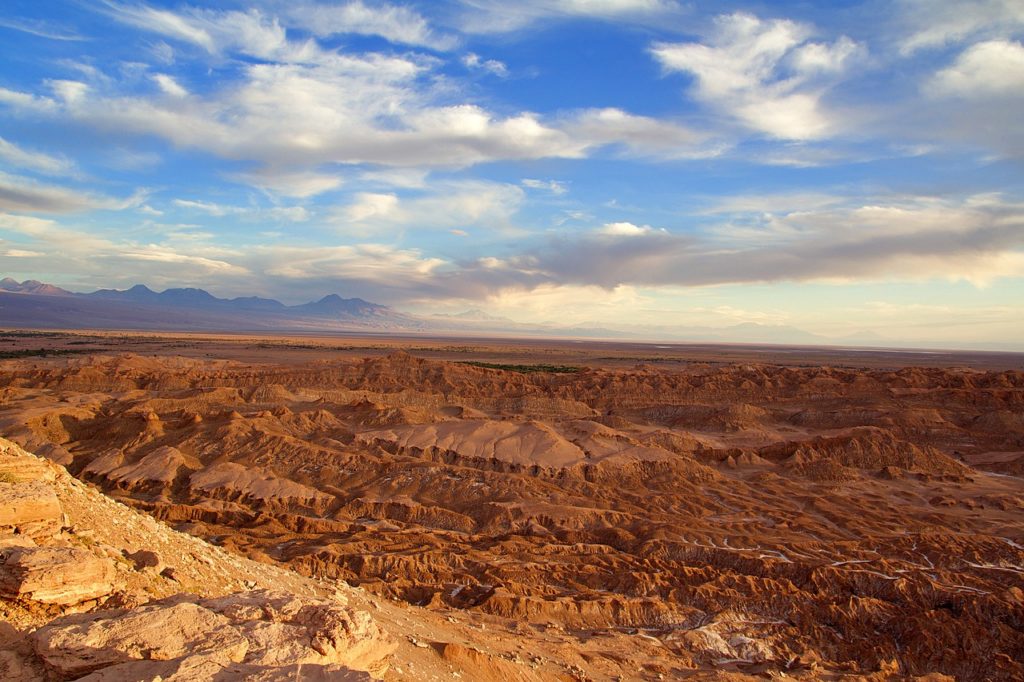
[651, 13, 863, 140]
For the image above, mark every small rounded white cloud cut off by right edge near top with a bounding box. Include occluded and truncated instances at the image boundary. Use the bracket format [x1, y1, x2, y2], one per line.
[928, 40, 1024, 98]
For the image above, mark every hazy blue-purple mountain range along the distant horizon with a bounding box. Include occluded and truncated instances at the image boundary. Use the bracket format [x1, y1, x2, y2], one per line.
[0, 278, 1024, 350]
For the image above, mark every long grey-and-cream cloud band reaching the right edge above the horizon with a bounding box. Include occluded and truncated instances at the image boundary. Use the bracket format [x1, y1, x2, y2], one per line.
[428, 195, 1024, 297]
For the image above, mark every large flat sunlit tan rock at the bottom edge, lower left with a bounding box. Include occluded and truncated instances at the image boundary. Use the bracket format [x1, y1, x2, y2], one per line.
[32, 591, 395, 680]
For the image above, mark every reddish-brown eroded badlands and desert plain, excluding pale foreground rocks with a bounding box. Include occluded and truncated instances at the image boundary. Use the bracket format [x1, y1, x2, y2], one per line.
[0, 332, 1024, 680]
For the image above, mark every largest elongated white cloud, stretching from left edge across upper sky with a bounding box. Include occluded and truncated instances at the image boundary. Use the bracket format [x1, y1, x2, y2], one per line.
[0, 54, 588, 168]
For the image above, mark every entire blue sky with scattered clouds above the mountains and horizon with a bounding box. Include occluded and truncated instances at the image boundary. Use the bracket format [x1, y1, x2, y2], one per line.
[0, 0, 1024, 348]
